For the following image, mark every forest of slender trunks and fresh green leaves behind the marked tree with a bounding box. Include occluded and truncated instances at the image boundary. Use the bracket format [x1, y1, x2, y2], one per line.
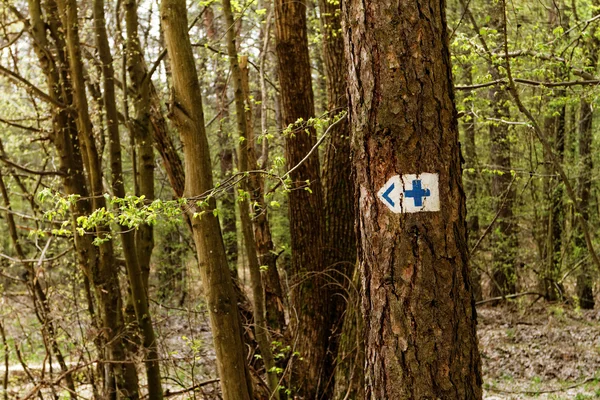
[0, 0, 600, 400]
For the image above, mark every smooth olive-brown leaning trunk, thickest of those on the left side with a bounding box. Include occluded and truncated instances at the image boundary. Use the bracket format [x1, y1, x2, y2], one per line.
[161, 0, 252, 400]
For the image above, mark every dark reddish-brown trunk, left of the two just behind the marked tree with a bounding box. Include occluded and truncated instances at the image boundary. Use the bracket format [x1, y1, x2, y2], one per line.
[275, 0, 329, 399]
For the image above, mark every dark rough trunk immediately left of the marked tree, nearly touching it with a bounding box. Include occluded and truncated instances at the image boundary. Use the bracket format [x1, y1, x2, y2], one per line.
[319, 0, 356, 392]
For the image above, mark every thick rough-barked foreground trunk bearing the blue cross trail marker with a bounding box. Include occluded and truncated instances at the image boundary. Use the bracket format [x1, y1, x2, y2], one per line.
[342, 0, 482, 400]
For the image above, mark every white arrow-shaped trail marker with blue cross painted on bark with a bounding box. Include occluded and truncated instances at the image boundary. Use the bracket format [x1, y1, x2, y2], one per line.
[377, 172, 440, 213]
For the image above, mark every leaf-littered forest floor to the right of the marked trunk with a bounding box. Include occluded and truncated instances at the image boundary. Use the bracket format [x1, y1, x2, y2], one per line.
[477, 301, 600, 400]
